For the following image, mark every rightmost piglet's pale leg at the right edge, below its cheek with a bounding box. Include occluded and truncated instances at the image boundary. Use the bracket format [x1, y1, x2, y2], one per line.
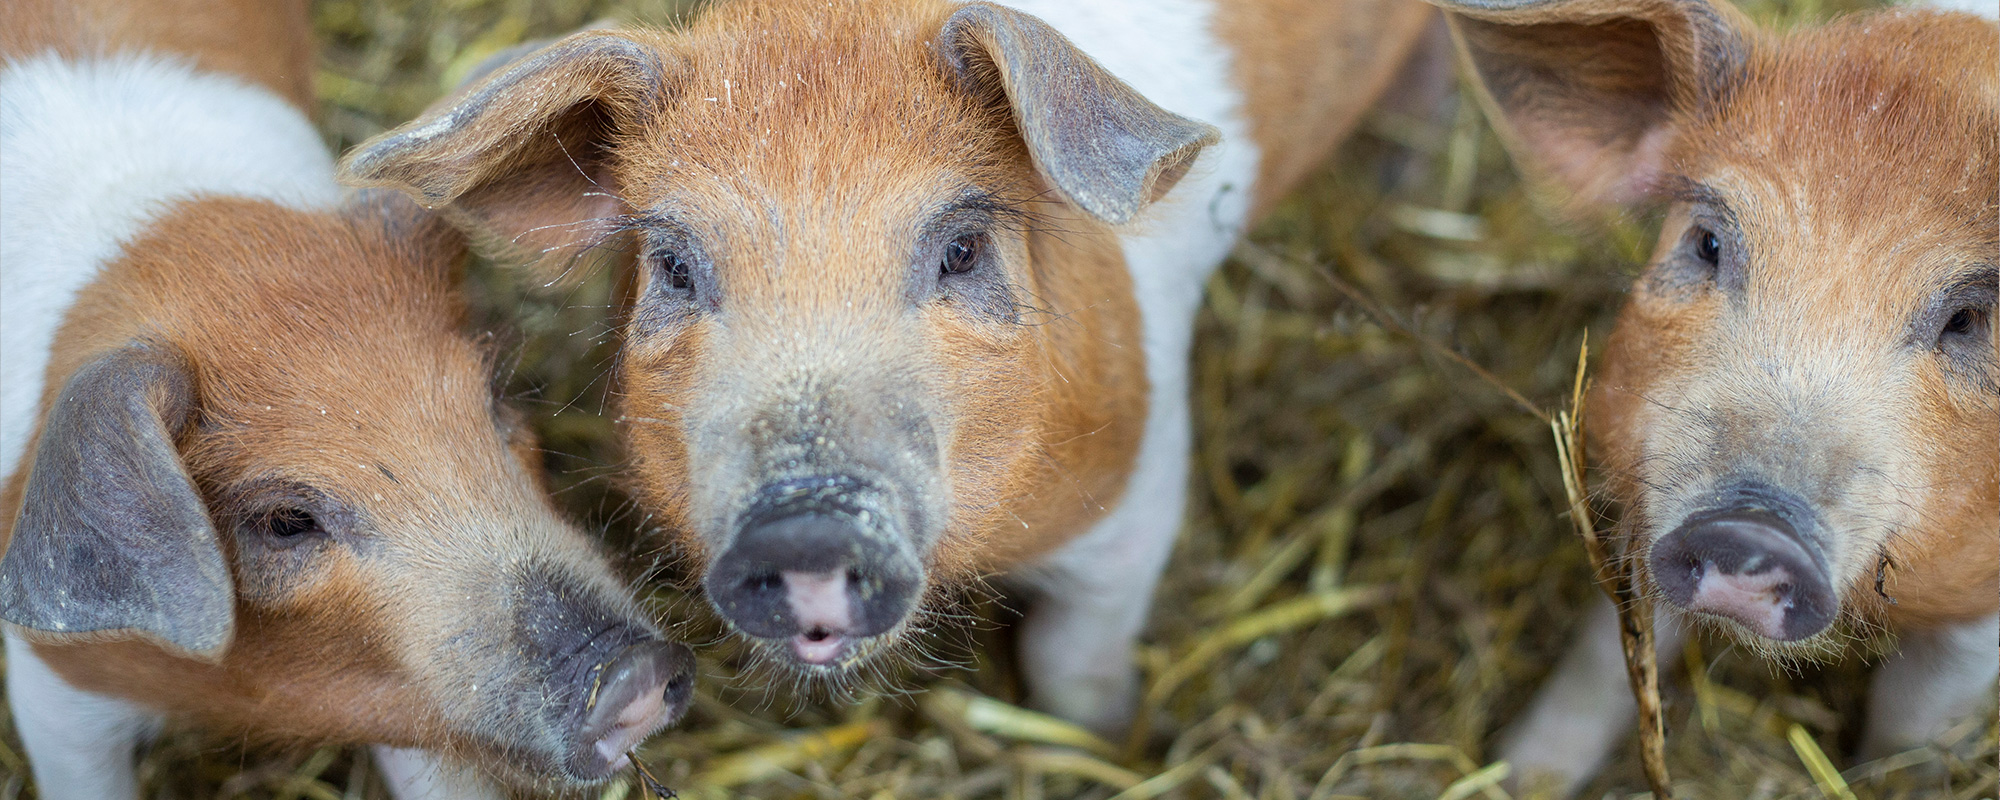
[1860, 616, 2000, 760]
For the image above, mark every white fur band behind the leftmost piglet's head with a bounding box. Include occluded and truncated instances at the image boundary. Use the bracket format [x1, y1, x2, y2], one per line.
[0, 54, 340, 478]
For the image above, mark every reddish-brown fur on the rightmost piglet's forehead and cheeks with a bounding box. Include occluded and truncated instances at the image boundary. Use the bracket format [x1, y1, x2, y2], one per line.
[1590, 12, 2000, 628]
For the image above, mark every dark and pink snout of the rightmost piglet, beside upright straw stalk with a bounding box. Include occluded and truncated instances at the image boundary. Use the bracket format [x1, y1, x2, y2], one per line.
[1650, 506, 1840, 642]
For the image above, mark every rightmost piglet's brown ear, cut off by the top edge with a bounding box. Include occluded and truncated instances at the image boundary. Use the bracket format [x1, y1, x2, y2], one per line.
[1432, 0, 1748, 204]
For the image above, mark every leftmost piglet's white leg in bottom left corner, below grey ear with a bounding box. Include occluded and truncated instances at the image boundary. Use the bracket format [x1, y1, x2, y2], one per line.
[6, 632, 160, 800]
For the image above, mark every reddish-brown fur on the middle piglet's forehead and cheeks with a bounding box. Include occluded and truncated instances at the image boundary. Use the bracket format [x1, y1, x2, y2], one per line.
[614, 4, 1144, 574]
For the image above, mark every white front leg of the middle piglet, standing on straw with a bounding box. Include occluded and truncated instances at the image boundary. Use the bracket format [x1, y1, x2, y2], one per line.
[1020, 396, 1192, 734]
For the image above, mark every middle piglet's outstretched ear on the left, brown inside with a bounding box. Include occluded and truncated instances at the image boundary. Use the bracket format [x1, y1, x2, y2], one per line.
[340, 30, 668, 272]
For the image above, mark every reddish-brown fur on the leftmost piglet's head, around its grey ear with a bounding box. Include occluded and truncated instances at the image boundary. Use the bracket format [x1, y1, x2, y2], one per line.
[0, 200, 476, 744]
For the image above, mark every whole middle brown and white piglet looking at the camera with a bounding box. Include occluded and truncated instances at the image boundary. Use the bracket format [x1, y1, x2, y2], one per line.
[344, 0, 1430, 728]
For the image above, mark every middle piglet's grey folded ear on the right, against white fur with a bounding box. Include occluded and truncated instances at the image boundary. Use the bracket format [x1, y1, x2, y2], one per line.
[938, 2, 1220, 224]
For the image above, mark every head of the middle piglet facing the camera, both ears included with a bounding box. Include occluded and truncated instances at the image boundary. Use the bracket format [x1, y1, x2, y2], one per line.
[344, 2, 1216, 676]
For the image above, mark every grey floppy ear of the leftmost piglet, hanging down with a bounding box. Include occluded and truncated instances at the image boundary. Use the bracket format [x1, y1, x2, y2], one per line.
[0, 344, 236, 660]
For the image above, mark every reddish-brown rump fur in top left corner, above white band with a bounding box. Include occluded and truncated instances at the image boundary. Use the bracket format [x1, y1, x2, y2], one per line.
[0, 0, 318, 114]
